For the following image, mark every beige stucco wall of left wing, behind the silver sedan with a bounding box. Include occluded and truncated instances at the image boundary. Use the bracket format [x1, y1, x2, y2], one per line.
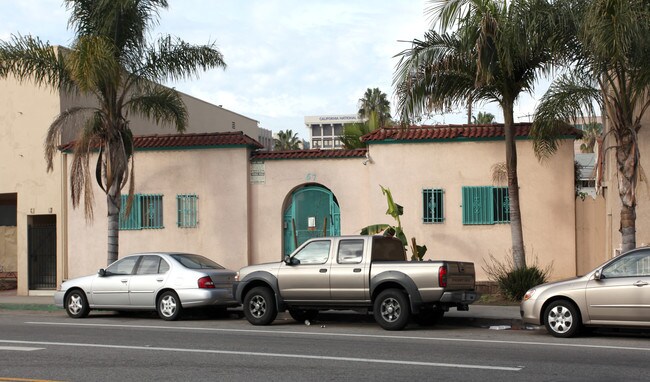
[63, 147, 249, 277]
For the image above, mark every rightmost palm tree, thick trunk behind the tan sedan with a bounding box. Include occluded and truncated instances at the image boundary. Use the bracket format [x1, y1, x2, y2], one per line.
[533, 0, 650, 251]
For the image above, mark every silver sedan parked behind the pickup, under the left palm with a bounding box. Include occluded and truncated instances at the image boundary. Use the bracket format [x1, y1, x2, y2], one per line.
[54, 252, 237, 321]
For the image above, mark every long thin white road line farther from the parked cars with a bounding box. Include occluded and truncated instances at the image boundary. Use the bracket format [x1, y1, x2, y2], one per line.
[0, 340, 523, 371]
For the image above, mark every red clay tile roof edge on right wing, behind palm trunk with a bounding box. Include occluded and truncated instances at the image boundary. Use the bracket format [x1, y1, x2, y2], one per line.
[361, 123, 581, 142]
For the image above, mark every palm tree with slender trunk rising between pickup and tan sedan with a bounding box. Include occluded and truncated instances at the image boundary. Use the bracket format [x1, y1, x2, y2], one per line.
[393, 0, 555, 268]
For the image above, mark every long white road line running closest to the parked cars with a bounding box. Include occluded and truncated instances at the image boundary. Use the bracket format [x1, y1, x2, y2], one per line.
[25, 322, 650, 351]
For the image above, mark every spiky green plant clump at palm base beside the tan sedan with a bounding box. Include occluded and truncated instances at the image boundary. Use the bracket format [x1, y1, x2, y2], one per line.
[483, 255, 551, 301]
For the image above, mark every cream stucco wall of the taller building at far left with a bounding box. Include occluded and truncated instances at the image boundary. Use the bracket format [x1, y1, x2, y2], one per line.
[0, 77, 62, 294]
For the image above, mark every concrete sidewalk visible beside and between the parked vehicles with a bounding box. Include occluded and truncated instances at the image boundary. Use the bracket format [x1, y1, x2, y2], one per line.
[0, 290, 524, 329]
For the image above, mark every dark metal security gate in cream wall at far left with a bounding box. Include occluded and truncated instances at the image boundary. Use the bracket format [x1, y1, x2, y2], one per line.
[27, 224, 56, 290]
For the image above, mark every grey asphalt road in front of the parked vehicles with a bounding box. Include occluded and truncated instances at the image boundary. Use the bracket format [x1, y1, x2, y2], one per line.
[0, 311, 650, 382]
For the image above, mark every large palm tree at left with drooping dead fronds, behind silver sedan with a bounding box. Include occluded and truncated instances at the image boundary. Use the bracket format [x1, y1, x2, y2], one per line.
[0, 0, 226, 264]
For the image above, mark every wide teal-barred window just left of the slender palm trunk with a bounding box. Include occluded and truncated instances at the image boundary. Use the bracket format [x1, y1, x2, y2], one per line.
[462, 186, 510, 225]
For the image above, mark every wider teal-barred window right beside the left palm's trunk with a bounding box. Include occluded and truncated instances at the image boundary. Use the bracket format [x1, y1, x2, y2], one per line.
[120, 194, 164, 230]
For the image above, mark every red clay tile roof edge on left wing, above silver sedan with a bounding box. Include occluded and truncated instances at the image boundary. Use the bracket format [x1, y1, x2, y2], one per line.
[59, 131, 264, 151]
